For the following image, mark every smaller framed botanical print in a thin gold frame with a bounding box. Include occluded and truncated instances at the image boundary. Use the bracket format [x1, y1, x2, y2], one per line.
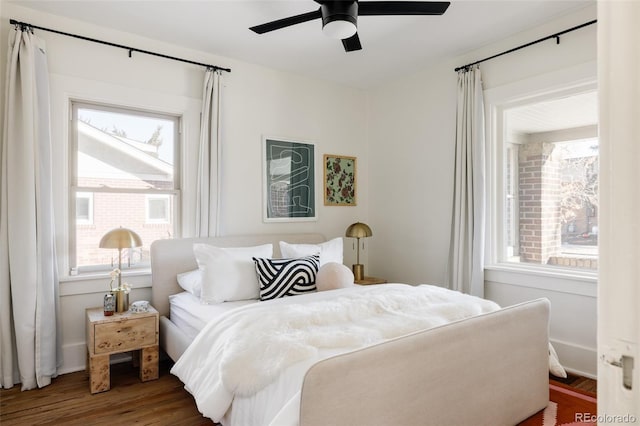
[323, 154, 356, 206]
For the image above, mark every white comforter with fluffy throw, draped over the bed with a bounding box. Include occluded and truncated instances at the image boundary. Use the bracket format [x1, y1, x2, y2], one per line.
[171, 284, 499, 425]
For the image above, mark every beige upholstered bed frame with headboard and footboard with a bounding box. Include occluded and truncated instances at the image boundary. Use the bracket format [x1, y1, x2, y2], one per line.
[151, 234, 549, 426]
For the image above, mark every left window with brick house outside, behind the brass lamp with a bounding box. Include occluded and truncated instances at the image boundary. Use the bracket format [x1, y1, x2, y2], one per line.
[70, 102, 180, 273]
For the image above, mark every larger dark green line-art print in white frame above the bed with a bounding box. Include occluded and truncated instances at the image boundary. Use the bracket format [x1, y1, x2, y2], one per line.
[262, 137, 317, 222]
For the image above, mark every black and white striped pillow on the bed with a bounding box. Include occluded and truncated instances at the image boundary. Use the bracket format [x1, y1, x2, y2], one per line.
[253, 255, 320, 300]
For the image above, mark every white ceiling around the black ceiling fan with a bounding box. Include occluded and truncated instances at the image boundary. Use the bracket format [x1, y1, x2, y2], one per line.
[8, 0, 595, 88]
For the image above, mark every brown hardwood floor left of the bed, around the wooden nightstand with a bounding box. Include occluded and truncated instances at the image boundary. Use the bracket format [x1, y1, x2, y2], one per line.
[0, 362, 214, 426]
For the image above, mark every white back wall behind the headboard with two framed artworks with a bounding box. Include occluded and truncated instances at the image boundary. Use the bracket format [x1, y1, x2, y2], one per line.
[0, 3, 369, 372]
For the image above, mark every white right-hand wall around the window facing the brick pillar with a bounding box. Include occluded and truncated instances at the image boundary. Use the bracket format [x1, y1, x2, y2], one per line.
[367, 7, 596, 376]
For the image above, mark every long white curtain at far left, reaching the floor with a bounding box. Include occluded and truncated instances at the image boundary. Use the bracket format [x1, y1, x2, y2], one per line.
[0, 28, 62, 390]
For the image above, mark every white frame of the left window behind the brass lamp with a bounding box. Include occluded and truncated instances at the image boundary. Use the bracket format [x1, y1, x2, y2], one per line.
[67, 98, 184, 276]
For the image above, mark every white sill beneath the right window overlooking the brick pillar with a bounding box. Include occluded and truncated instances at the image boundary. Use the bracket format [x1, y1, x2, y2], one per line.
[485, 264, 598, 297]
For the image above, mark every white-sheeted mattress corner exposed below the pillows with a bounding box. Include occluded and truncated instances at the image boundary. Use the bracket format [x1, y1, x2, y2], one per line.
[169, 291, 259, 340]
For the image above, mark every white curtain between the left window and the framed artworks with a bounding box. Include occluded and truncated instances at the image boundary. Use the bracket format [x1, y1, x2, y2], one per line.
[196, 69, 222, 237]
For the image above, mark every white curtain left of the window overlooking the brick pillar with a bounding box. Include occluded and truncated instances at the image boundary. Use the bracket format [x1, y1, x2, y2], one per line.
[448, 67, 485, 297]
